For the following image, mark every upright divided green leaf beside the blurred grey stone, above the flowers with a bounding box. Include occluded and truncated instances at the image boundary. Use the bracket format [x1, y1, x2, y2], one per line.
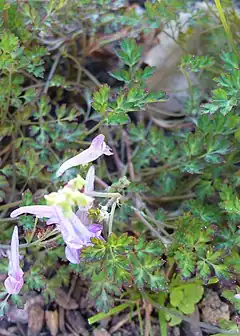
[93, 39, 165, 125]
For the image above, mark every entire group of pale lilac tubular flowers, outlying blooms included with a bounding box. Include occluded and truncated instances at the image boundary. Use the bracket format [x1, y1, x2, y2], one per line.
[5, 134, 112, 294]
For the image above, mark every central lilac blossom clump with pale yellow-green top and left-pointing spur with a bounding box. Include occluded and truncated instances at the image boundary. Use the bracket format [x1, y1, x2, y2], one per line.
[11, 167, 102, 264]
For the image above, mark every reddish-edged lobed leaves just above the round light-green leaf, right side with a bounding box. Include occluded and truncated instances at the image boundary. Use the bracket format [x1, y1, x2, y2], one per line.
[171, 214, 239, 280]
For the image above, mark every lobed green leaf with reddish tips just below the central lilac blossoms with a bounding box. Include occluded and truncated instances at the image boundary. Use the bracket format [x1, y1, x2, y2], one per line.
[81, 234, 166, 312]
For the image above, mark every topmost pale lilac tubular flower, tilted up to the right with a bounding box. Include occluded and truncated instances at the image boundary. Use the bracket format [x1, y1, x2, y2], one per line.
[56, 134, 112, 177]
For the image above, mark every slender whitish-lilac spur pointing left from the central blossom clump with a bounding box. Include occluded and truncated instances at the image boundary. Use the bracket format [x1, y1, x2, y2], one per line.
[10, 205, 54, 218]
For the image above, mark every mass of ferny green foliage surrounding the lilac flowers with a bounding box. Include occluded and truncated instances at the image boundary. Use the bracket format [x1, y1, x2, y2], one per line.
[0, 0, 240, 331]
